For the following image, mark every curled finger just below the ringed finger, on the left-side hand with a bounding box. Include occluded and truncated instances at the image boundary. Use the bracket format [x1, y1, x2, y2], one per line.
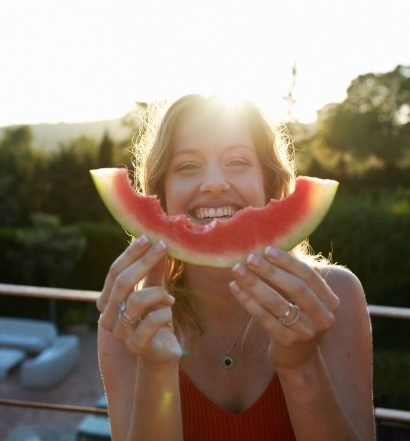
[125, 307, 172, 355]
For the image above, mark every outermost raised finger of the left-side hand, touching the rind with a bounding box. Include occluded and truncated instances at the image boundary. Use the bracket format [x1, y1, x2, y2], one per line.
[97, 235, 149, 312]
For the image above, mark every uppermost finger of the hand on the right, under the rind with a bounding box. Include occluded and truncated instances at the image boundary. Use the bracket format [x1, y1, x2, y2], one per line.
[265, 247, 340, 311]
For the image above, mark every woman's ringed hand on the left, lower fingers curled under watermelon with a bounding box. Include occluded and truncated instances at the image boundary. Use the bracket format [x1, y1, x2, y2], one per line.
[97, 236, 182, 367]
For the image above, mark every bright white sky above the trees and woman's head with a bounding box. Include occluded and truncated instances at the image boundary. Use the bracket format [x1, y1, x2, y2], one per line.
[0, 0, 410, 126]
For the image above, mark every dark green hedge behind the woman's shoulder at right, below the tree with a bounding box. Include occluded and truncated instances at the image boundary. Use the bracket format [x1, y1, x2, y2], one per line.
[310, 188, 410, 306]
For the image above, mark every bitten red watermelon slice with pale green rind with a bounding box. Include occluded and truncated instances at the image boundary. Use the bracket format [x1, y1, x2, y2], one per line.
[90, 168, 339, 267]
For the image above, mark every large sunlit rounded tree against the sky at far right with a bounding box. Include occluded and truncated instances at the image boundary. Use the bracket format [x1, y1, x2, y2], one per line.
[313, 66, 410, 172]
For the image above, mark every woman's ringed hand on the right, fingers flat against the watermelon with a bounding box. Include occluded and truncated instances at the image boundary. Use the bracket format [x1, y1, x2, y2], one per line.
[230, 247, 339, 372]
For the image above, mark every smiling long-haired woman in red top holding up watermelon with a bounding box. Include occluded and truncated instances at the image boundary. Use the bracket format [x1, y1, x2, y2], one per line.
[98, 95, 374, 441]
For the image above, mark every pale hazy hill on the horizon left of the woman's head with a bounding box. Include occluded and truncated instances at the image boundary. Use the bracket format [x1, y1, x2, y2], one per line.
[0, 119, 132, 151]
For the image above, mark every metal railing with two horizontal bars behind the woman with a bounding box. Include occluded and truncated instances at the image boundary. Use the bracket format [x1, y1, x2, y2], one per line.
[0, 283, 410, 423]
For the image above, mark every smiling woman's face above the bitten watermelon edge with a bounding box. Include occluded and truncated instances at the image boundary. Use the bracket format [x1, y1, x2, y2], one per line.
[164, 108, 266, 224]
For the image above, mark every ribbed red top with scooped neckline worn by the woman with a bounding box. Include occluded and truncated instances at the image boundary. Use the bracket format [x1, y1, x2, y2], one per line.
[180, 370, 296, 441]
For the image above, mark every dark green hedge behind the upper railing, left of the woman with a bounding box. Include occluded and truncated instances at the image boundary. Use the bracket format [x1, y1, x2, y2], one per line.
[0, 222, 129, 327]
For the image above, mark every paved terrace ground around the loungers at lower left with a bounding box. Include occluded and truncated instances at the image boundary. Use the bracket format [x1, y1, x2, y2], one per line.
[0, 329, 103, 441]
